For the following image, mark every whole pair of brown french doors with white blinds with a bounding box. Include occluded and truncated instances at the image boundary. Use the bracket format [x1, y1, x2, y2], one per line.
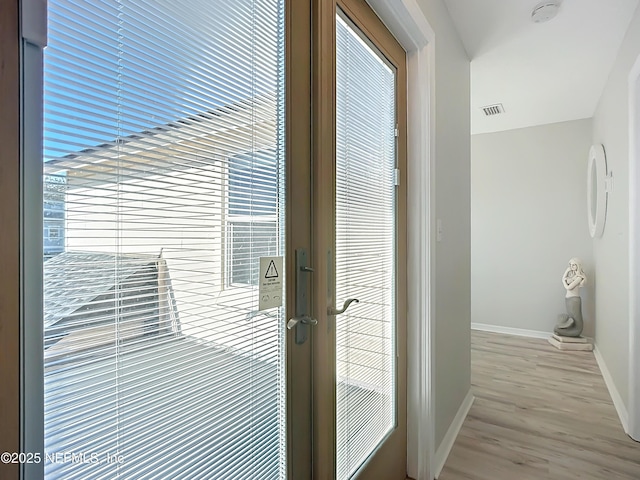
[30, 0, 406, 480]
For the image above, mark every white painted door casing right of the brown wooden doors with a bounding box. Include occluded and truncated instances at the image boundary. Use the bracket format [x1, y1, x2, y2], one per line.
[332, 0, 436, 480]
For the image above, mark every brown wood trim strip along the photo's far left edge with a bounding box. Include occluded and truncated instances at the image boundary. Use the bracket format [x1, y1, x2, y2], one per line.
[0, 0, 20, 480]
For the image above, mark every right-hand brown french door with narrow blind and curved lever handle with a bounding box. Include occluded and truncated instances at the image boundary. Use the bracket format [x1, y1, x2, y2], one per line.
[313, 0, 406, 479]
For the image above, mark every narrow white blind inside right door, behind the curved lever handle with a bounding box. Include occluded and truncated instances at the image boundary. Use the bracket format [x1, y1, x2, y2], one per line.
[336, 14, 396, 479]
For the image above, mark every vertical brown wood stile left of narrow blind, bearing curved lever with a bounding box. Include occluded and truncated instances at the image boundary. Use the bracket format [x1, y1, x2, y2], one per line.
[312, 0, 336, 479]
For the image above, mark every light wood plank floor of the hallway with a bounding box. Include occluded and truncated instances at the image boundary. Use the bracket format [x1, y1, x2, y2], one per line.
[439, 331, 640, 480]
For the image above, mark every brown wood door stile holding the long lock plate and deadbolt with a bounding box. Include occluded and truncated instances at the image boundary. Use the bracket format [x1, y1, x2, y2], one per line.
[285, 0, 312, 480]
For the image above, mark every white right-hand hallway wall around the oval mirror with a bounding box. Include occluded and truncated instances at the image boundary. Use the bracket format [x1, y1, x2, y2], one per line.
[593, 2, 640, 407]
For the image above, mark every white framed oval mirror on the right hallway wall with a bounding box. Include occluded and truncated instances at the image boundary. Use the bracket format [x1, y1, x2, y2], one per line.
[587, 145, 609, 238]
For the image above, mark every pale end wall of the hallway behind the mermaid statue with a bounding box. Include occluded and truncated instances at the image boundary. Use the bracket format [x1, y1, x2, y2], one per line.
[471, 119, 594, 336]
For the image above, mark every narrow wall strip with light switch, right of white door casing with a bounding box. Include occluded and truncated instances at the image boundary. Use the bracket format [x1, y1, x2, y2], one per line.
[416, 0, 471, 450]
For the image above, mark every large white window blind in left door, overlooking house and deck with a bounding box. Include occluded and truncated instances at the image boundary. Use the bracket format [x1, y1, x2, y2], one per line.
[43, 0, 286, 480]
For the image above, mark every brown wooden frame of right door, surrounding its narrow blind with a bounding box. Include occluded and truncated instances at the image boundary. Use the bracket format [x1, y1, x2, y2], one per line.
[313, 0, 408, 478]
